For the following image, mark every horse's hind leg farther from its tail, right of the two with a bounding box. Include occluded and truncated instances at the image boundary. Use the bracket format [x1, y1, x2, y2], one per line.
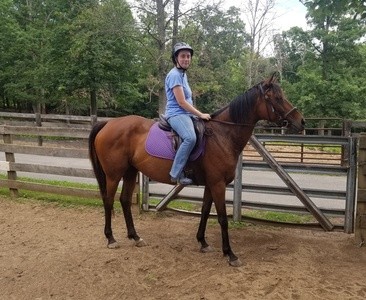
[119, 167, 146, 247]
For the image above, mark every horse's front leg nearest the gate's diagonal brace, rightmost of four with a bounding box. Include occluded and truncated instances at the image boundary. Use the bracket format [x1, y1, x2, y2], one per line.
[210, 182, 242, 267]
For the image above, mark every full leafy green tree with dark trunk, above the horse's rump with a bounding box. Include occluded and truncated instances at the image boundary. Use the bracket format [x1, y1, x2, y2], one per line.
[68, 0, 137, 115]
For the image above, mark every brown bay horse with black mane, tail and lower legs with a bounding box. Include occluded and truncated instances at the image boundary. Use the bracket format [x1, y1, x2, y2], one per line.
[89, 76, 305, 266]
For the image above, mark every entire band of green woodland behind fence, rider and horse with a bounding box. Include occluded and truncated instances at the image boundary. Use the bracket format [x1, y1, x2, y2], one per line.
[0, 0, 366, 119]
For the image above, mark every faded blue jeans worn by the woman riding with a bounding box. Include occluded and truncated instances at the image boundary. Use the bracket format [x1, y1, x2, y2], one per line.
[168, 114, 197, 179]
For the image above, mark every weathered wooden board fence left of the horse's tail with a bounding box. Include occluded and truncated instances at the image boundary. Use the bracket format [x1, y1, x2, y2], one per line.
[0, 125, 100, 198]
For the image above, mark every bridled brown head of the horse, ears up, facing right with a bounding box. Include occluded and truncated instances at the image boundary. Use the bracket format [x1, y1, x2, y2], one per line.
[258, 73, 305, 133]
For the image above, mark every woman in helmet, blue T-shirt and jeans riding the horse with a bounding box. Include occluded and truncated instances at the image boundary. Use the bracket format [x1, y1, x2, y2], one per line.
[165, 43, 211, 185]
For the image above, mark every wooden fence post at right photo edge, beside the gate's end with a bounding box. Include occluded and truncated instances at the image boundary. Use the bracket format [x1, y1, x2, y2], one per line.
[355, 133, 366, 246]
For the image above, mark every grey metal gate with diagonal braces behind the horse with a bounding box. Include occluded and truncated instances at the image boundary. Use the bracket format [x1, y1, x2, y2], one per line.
[140, 134, 357, 233]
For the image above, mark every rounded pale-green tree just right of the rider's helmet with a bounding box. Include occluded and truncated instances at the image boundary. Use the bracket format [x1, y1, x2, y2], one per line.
[180, 5, 249, 111]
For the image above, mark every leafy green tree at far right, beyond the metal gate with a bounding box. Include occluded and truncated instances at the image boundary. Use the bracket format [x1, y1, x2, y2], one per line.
[284, 0, 366, 118]
